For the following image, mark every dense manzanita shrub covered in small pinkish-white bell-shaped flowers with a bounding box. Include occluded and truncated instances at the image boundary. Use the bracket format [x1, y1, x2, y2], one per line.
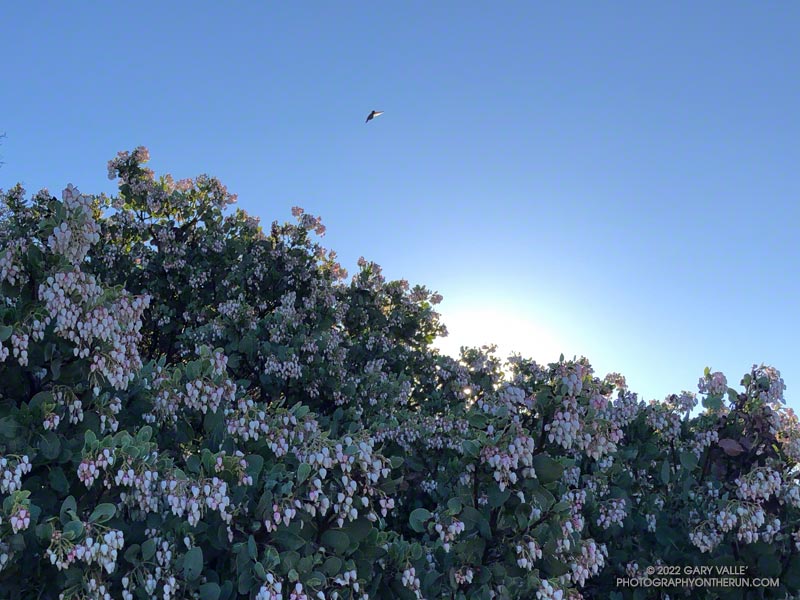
[0, 148, 800, 600]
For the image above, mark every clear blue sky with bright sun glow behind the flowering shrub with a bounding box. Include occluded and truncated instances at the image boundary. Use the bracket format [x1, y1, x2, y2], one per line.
[0, 0, 800, 408]
